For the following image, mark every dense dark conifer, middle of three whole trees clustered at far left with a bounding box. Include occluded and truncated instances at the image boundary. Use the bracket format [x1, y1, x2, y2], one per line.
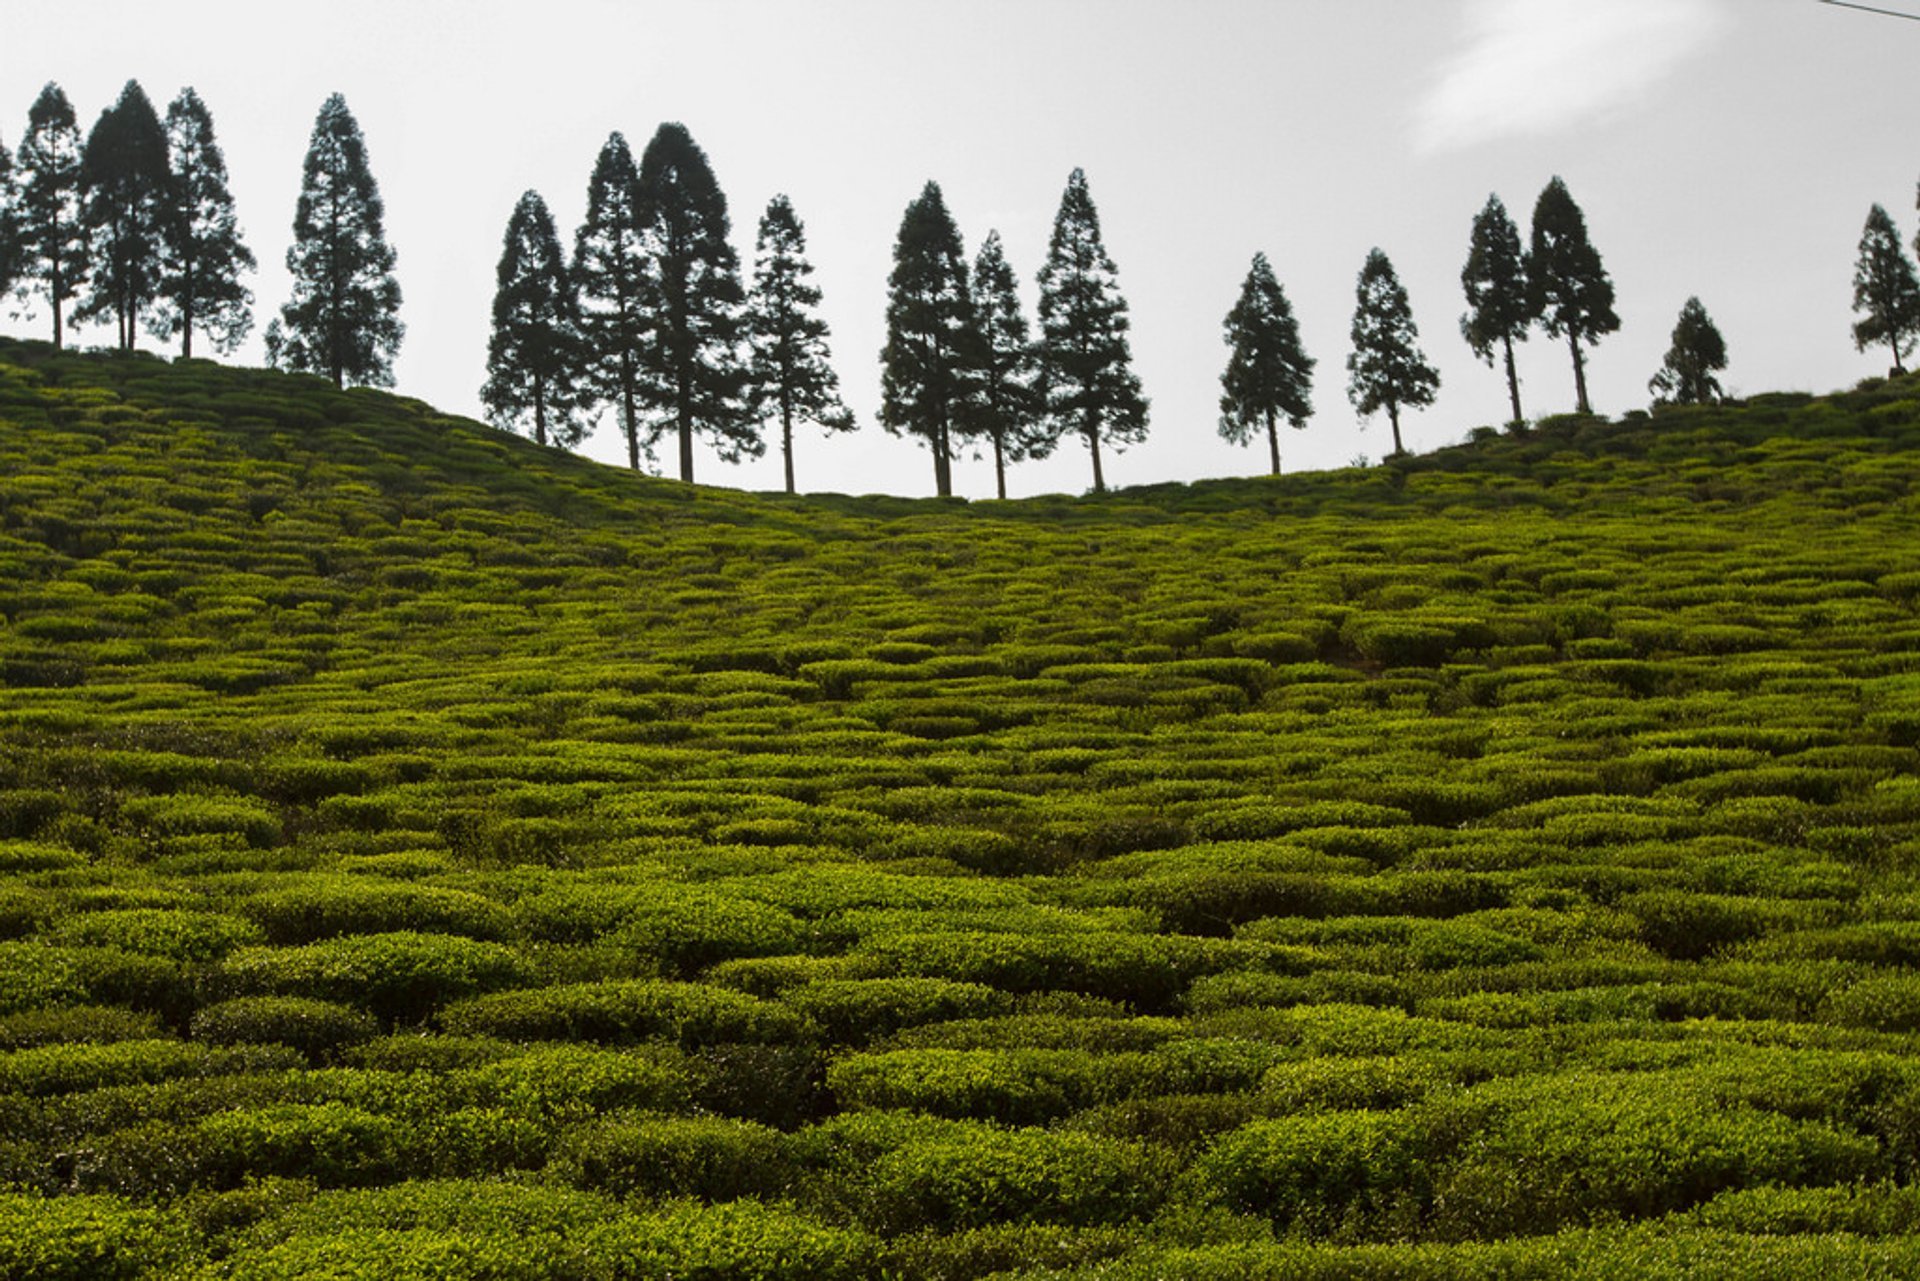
[73, 81, 175, 351]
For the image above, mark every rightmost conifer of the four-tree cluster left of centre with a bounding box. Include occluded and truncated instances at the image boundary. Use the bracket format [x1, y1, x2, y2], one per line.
[747, 196, 854, 494]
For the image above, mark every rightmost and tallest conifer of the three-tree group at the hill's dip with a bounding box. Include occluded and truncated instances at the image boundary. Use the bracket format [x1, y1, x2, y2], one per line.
[1041, 169, 1146, 494]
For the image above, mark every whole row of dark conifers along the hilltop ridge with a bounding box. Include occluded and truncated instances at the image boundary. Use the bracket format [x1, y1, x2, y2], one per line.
[11, 81, 1920, 497]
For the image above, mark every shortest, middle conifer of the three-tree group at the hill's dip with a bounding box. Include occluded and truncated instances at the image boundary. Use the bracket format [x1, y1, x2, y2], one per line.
[968, 230, 1054, 497]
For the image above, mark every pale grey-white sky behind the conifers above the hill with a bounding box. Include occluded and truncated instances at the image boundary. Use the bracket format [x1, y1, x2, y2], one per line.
[0, 0, 1920, 497]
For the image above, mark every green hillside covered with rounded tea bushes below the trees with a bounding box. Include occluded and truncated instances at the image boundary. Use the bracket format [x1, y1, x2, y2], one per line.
[0, 344, 1920, 1281]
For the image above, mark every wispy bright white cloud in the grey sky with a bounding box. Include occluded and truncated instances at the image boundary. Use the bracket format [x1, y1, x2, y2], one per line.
[1415, 0, 1726, 152]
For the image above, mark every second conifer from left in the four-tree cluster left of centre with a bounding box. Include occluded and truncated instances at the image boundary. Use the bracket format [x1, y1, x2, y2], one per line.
[574, 133, 660, 471]
